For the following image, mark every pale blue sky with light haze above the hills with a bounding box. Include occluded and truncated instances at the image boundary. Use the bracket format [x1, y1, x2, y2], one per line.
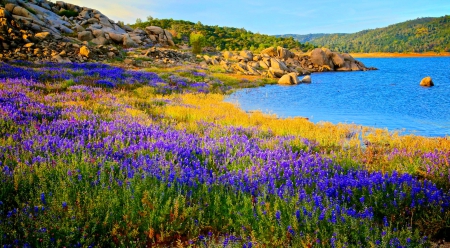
[66, 0, 450, 35]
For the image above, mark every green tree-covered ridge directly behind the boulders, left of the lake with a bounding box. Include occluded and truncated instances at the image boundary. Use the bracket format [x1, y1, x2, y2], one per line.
[131, 17, 314, 51]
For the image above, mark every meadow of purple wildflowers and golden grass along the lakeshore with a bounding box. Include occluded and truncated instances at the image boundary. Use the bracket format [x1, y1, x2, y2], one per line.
[0, 61, 450, 247]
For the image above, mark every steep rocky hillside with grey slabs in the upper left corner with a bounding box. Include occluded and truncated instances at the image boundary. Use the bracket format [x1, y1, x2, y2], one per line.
[0, 0, 174, 62]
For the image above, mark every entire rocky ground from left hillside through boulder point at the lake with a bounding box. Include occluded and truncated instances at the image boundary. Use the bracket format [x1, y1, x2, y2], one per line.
[0, 0, 373, 78]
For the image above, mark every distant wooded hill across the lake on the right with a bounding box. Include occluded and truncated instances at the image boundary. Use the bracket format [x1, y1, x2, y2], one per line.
[282, 15, 450, 53]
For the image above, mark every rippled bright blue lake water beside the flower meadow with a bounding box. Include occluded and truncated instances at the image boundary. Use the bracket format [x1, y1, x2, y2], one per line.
[226, 57, 450, 136]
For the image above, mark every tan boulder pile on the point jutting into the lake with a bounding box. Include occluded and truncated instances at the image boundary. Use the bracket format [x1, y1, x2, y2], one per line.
[203, 47, 376, 84]
